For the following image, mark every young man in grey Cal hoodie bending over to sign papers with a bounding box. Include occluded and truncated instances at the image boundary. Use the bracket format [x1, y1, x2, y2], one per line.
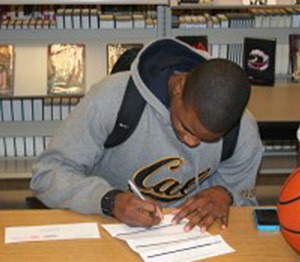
[31, 39, 262, 231]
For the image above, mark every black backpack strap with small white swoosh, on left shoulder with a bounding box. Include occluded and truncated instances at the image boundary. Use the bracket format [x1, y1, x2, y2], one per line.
[104, 77, 146, 148]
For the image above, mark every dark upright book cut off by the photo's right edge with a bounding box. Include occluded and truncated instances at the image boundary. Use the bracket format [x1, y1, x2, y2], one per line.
[289, 35, 300, 82]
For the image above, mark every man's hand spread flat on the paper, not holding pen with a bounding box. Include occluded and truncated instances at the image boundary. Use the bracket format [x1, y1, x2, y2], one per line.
[172, 186, 231, 232]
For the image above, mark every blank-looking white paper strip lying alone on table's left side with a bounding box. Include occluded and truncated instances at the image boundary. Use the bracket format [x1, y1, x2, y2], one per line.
[4, 223, 100, 244]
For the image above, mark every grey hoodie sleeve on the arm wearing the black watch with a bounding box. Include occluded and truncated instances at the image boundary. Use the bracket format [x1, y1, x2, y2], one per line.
[30, 73, 126, 214]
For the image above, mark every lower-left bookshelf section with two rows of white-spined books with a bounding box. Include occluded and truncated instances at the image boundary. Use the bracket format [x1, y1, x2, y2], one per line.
[0, 96, 81, 180]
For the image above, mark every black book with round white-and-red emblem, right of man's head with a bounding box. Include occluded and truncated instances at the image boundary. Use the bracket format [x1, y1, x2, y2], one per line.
[243, 37, 276, 85]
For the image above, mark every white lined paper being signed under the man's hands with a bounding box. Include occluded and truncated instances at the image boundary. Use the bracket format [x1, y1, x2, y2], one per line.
[102, 215, 235, 262]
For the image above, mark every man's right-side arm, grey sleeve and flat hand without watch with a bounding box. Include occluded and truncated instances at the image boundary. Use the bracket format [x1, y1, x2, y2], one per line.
[174, 113, 263, 231]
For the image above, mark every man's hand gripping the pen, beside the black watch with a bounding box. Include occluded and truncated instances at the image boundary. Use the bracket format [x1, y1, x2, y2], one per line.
[114, 191, 162, 227]
